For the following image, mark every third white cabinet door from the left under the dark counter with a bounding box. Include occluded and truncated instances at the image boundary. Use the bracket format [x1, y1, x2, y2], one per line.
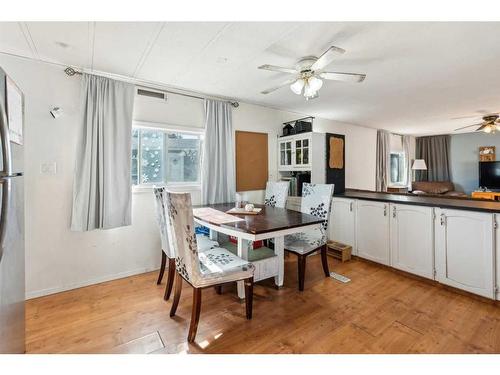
[390, 204, 434, 279]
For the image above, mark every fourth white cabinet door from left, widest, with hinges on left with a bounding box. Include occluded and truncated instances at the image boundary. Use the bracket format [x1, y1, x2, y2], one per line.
[435, 209, 495, 298]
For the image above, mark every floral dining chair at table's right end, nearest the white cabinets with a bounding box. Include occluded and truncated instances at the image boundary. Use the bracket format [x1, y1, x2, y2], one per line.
[285, 183, 333, 291]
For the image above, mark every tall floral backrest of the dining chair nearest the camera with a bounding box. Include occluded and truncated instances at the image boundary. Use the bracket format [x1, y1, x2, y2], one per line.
[165, 190, 202, 283]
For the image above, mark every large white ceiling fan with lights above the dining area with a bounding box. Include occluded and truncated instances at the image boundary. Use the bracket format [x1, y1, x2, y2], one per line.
[259, 46, 366, 100]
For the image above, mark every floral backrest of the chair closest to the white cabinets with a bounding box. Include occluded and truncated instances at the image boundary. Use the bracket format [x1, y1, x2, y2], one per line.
[300, 182, 334, 230]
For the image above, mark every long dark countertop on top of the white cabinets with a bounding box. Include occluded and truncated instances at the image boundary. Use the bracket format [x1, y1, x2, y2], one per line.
[334, 190, 500, 213]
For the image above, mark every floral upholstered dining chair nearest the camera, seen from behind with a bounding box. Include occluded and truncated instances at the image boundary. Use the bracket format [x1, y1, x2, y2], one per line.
[165, 191, 255, 342]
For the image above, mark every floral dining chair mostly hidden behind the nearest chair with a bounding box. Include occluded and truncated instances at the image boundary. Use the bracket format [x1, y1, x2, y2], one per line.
[153, 186, 219, 301]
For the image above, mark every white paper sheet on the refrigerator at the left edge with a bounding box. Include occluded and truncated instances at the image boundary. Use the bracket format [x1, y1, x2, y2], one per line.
[5, 76, 24, 145]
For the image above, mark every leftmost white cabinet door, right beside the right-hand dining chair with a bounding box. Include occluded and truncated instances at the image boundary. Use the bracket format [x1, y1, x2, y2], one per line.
[328, 198, 357, 255]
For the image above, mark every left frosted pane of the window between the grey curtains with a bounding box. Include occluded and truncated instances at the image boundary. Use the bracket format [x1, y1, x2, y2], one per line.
[140, 129, 165, 184]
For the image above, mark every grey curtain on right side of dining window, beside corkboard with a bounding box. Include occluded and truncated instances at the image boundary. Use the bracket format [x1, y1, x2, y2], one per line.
[201, 99, 236, 204]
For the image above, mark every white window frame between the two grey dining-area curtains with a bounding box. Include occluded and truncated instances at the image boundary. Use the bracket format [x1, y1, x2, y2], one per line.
[132, 121, 205, 193]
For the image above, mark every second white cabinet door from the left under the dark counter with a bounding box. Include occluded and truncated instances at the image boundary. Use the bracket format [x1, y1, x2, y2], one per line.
[356, 200, 390, 265]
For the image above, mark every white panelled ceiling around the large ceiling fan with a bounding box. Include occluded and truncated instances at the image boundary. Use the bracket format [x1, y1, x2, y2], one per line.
[0, 22, 500, 134]
